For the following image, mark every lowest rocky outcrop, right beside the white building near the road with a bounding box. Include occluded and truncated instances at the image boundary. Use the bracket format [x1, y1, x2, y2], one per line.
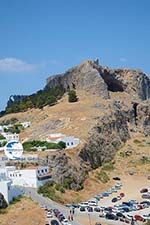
[39, 151, 88, 190]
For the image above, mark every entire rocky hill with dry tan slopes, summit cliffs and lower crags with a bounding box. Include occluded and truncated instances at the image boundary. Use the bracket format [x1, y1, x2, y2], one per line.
[0, 60, 150, 189]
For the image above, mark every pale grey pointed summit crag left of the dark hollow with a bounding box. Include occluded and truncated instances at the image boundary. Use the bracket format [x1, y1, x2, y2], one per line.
[46, 61, 109, 99]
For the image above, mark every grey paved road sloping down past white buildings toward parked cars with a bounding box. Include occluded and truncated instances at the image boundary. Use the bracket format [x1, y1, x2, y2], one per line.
[23, 188, 81, 225]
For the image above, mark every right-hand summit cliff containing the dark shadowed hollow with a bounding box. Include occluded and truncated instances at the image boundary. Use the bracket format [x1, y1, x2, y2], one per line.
[99, 68, 150, 100]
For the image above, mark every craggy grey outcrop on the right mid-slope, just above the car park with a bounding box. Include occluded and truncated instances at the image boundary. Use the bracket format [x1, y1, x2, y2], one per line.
[79, 110, 130, 168]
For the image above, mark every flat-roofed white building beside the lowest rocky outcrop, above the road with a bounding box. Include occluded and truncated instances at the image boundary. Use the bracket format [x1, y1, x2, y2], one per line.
[6, 166, 51, 188]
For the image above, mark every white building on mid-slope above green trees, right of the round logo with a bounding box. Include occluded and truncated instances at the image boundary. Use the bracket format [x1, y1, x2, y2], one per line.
[46, 133, 80, 148]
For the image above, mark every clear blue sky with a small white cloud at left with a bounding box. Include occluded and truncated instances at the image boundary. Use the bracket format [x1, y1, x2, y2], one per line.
[0, 0, 150, 109]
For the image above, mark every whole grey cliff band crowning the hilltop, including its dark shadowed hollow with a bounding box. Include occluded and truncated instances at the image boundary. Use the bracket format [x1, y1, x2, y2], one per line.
[46, 61, 150, 100]
